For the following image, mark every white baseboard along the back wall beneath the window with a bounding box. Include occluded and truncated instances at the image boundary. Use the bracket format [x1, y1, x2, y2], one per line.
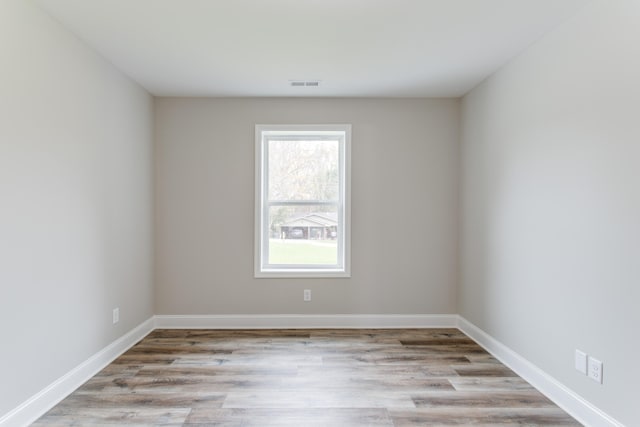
[155, 314, 458, 329]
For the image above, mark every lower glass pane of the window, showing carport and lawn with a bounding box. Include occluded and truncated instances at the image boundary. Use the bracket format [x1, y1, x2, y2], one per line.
[268, 205, 338, 265]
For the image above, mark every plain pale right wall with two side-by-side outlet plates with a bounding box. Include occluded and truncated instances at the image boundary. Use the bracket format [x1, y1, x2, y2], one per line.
[460, 0, 640, 426]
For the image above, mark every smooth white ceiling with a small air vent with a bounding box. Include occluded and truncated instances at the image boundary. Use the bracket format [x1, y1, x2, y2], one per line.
[35, 0, 587, 97]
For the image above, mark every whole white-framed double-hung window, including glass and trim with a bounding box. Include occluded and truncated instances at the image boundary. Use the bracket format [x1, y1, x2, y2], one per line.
[255, 125, 351, 277]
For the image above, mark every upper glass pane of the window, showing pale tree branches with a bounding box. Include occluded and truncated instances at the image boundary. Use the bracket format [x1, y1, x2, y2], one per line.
[268, 140, 340, 201]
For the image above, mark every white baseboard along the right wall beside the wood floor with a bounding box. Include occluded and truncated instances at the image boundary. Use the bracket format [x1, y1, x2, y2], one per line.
[458, 316, 624, 427]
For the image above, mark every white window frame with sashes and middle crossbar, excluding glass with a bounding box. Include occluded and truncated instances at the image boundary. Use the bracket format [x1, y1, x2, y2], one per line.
[254, 124, 351, 278]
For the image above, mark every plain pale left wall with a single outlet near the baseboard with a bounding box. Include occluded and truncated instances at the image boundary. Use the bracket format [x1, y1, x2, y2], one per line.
[0, 0, 153, 418]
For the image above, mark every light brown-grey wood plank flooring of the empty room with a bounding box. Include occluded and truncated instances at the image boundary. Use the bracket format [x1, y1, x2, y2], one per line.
[34, 329, 580, 427]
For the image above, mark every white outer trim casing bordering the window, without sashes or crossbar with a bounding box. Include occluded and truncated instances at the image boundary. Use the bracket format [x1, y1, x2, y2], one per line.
[254, 124, 351, 278]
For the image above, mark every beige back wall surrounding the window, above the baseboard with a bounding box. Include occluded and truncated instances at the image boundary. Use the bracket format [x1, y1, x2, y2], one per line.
[155, 98, 459, 314]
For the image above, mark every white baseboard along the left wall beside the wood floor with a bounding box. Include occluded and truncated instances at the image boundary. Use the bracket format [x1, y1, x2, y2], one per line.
[0, 317, 154, 427]
